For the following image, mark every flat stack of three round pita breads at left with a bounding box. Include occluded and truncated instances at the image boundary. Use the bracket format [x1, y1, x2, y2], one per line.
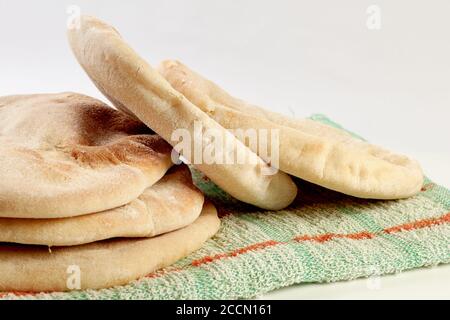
[0, 93, 219, 291]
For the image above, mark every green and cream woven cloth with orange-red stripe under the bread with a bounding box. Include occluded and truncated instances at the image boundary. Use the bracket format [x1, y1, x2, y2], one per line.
[1, 115, 450, 299]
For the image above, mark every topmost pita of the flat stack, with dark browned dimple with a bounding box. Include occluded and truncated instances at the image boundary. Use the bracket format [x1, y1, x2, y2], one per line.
[0, 93, 172, 218]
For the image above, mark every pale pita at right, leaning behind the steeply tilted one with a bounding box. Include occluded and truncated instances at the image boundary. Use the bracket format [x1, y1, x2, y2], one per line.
[159, 61, 423, 199]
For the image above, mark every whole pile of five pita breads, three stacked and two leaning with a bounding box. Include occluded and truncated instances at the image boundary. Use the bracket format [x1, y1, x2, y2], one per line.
[0, 16, 423, 291]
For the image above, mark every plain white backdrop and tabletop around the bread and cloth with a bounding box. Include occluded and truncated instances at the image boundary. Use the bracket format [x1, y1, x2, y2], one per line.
[0, 0, 450, 298]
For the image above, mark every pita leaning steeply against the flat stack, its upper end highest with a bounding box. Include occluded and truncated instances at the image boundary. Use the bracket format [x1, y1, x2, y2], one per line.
[68, 16, 297, 210]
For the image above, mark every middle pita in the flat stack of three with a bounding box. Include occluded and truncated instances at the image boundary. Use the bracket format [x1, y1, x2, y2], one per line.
[0, 165, 204, 246]
